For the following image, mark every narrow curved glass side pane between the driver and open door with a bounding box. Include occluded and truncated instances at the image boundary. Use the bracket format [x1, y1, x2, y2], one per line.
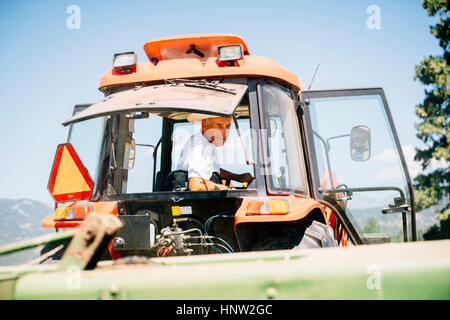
[258, 84, 307, 194]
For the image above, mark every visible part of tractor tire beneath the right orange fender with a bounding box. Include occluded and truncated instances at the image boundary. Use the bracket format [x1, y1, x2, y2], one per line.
[294, 220, 337, 249]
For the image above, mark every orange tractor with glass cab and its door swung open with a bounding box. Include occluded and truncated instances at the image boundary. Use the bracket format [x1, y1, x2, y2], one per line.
[42, 34, 415, 259]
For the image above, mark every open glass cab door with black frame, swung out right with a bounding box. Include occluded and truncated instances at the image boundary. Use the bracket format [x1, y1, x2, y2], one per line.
[298, 88, 416, 244]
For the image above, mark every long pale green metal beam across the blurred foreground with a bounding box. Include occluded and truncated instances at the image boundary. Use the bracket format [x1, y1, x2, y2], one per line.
[4, 240, 450, 300]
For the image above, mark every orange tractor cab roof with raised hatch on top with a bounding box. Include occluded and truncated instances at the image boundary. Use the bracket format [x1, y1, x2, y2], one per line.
[99, 33, 303, 91]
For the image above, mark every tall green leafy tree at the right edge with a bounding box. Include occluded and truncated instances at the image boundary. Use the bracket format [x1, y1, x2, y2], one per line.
[414, 0, 450, 238]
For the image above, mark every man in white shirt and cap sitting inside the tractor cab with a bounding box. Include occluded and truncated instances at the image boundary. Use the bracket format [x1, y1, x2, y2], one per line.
[177, 114, 254, 191]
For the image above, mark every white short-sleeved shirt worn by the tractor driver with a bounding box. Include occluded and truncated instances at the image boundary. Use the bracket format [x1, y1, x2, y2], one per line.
[177, 132, 220, 180]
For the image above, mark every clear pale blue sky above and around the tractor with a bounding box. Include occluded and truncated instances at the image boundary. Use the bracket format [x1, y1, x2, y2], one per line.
[0, 0, 441, 202]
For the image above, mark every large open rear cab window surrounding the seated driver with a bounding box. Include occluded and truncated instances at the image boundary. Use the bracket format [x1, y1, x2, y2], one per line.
[107, 91, 254, 194]
